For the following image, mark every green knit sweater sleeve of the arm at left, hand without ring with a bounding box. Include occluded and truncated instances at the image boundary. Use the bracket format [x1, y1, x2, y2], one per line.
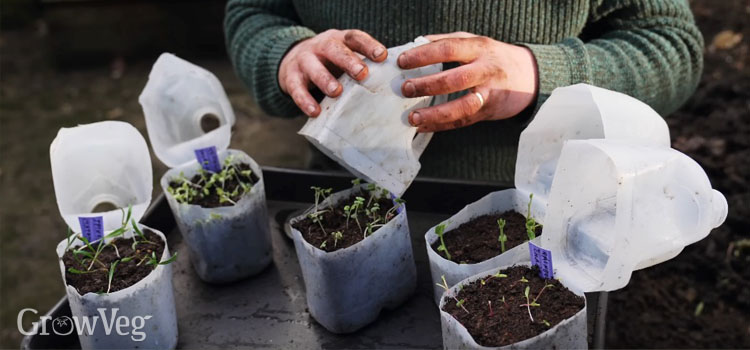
[224, 0, 315, 117]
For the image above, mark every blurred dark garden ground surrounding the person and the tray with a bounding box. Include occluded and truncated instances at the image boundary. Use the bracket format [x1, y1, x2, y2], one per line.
[0, 0, 750, 348]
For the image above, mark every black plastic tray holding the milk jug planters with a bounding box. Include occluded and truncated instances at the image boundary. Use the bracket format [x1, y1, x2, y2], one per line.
[21, 167, 606, 349]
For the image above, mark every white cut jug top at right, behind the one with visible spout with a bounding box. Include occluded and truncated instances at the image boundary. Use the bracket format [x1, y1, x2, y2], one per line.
[515, 84, 670, 203]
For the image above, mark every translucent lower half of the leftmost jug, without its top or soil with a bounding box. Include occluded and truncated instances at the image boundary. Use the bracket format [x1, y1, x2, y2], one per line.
[57, 224, 177, 349]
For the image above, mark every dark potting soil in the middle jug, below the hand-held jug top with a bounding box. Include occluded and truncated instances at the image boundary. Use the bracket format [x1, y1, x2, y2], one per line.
[292, 191, 396, 252]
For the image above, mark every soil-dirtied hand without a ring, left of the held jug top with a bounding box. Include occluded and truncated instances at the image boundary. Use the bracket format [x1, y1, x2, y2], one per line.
[278, 29, 388, 117]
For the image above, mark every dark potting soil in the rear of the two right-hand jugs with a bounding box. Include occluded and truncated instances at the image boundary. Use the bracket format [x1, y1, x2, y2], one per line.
[432, 210, 542, 264]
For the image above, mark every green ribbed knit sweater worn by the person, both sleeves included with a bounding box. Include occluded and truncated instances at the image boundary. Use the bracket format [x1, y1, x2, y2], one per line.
[225, 0, 703, 182]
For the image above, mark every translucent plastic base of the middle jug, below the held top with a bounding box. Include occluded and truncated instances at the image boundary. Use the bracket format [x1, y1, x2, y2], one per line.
[290, 185, 417, 333]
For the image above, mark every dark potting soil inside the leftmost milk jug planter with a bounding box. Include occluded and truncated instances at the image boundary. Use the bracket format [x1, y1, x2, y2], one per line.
[63, 229, 164, 295]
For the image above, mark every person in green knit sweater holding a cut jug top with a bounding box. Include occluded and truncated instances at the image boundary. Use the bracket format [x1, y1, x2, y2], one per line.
[224, 0, 703, 183]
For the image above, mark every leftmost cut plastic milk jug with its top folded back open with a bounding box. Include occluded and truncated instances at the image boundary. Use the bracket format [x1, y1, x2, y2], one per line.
[50, 121, 177, 349]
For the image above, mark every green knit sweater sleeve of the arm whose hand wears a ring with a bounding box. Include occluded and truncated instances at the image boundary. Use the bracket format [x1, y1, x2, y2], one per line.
[525, 0, 703, 115]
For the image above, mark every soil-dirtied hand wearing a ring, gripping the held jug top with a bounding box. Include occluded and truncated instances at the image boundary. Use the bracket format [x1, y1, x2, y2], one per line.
[398, 33, 537, 132]
